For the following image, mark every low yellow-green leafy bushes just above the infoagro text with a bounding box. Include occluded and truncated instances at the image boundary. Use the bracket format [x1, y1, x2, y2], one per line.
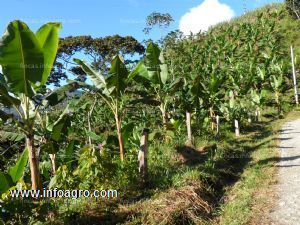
[50, 147, 138, 191]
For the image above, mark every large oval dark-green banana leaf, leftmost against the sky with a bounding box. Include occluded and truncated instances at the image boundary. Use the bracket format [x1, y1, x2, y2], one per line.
[0, 21, 44, 97]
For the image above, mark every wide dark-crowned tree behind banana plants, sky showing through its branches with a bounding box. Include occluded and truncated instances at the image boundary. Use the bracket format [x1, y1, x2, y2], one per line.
[47, 35, 145, 86]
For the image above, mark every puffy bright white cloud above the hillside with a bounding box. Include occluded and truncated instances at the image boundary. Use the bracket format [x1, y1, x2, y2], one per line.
[179, 0, 234, 35]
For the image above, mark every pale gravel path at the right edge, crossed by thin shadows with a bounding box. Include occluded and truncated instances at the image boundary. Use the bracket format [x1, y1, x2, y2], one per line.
[269, 120, 300, 225]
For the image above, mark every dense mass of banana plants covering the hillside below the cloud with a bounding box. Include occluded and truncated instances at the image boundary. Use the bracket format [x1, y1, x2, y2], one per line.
[165, 7, 288, 125]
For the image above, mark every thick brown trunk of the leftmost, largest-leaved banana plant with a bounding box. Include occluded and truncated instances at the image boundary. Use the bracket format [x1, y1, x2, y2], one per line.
[26, 135, 43, 190]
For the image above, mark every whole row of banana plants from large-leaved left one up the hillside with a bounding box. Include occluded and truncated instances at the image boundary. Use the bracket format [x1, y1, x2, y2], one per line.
[0, 9, 291, 193]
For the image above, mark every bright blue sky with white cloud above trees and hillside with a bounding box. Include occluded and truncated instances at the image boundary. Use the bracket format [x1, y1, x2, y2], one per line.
[0, 0, 283, 41]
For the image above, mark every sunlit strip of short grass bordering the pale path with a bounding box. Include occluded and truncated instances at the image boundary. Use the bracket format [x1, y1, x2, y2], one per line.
[215, 108, 300, 225]
